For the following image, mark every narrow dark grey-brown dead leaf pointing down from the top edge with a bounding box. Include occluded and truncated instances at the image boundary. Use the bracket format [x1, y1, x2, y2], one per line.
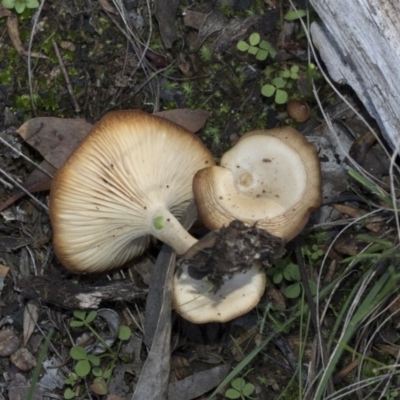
[154, 0, 179, 49]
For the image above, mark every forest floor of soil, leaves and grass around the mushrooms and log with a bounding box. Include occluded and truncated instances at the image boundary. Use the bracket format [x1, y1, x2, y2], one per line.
[0, 0, 400, 400]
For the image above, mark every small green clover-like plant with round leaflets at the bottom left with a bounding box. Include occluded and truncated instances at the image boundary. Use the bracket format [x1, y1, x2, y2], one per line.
[64, 311, 131, 399]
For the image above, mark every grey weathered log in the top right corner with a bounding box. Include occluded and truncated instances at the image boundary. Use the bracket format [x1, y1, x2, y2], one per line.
[310, 0, 400, 149]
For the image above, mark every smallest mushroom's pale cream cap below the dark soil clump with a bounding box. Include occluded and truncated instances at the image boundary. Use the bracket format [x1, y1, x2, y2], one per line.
[172, 263, 266, 324]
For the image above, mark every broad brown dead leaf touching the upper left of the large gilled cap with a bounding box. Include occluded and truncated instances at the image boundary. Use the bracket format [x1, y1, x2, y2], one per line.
[17, 117, 92, 169]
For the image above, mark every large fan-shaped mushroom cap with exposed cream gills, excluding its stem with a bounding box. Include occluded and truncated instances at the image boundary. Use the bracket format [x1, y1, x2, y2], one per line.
[50, 110, 214, 273]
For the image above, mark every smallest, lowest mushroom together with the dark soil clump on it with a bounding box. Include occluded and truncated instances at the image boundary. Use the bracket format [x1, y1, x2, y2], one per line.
[172, 220, 284, 324]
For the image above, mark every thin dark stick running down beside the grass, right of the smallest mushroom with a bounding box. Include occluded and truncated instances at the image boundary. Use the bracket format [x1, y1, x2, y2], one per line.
[295, 237, 334, 393]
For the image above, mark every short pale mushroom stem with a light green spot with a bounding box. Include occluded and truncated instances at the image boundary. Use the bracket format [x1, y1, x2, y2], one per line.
[149, 207, 197, 255]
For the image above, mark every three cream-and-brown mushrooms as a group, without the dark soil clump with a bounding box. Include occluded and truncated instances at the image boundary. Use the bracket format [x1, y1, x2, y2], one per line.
[50, 110, 321, 323]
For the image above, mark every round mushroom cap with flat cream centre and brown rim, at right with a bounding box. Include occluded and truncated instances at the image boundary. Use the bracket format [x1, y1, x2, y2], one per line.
[193, 127, 322, 241]
